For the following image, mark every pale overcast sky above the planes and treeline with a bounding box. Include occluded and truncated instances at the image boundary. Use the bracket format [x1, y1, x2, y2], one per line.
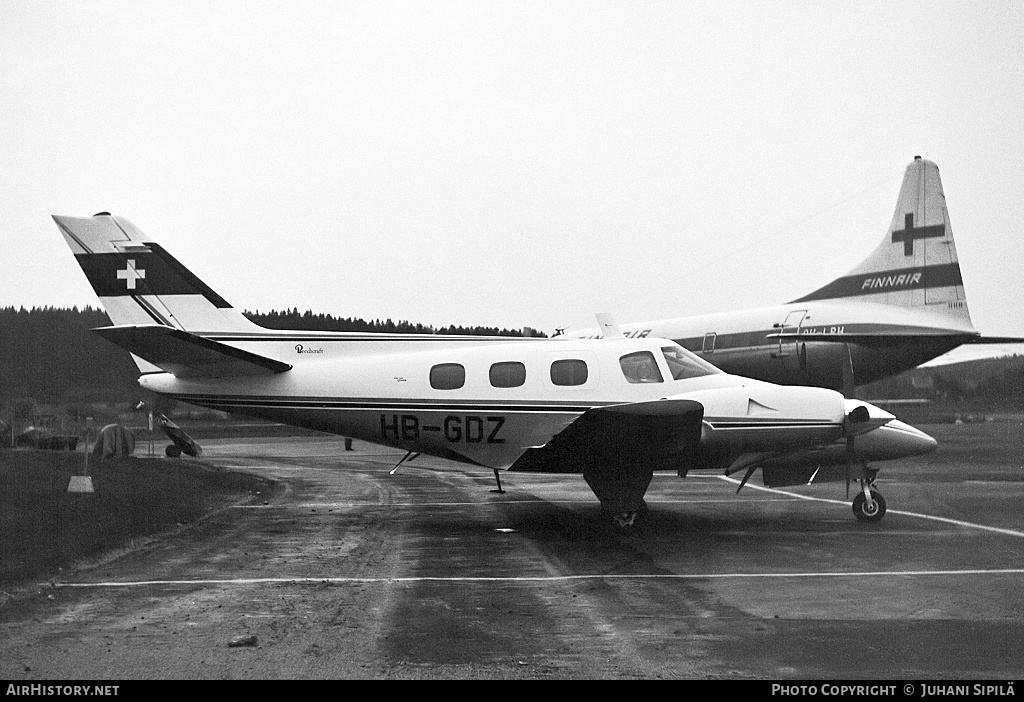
[0, 0, 1024, 352]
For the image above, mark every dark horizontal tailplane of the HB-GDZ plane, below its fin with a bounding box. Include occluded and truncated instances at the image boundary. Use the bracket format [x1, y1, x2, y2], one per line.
[92, 324, 292, 378]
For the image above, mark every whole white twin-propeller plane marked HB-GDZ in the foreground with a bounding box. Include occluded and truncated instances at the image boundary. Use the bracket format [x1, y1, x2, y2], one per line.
[54, 213, 936, 528]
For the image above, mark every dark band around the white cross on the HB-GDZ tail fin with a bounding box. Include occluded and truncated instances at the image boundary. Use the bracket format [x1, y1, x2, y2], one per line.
[75, 244, 230, 309]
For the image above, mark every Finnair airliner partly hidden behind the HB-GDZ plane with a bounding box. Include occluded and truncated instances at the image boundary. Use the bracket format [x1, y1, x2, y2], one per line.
[569, 157, 1024, 397]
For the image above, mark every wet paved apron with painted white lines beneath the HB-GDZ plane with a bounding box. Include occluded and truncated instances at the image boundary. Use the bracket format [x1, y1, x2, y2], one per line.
[0, 438, 1024, 681]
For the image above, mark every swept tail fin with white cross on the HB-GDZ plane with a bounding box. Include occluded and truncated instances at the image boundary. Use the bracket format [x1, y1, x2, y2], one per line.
[53, 212, 261, 332]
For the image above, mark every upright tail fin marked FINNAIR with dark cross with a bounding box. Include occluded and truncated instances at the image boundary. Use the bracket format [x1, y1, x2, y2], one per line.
[793, 156, 974, 330]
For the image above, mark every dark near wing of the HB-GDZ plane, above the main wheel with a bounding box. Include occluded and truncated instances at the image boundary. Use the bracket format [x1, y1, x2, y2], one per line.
[509, 399, 703, 476]
